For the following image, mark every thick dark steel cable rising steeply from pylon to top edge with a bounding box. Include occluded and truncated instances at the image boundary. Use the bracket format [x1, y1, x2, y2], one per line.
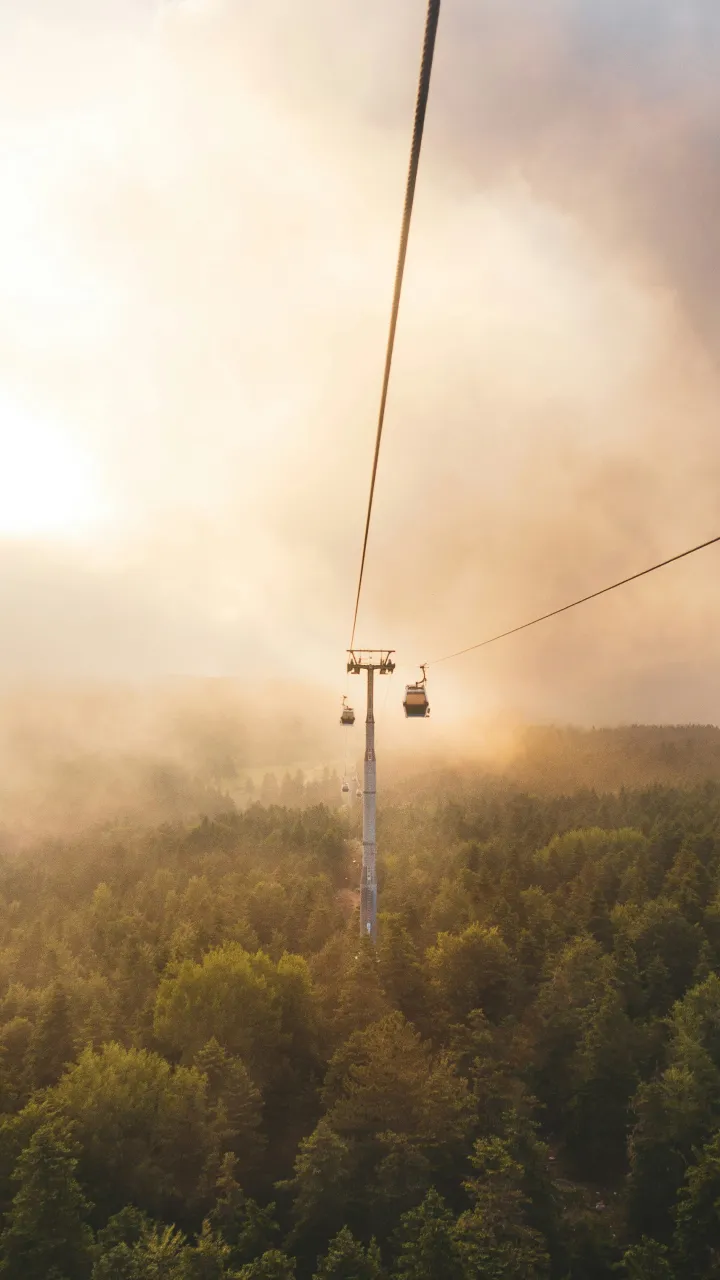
[350, 0, 441, 649]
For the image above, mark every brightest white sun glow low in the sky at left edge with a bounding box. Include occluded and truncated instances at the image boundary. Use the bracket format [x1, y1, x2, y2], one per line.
[0, 393, 104, 538]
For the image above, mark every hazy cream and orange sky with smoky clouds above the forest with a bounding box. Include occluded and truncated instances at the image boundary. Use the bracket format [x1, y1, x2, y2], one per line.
[0, 0, 720, 722]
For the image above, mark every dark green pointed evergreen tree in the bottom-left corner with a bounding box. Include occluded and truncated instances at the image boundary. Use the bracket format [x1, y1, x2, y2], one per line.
[0, 1121, 92, 1280]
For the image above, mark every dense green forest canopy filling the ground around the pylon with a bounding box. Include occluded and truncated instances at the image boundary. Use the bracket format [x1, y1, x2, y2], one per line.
[0, 742, 720, 1280]
